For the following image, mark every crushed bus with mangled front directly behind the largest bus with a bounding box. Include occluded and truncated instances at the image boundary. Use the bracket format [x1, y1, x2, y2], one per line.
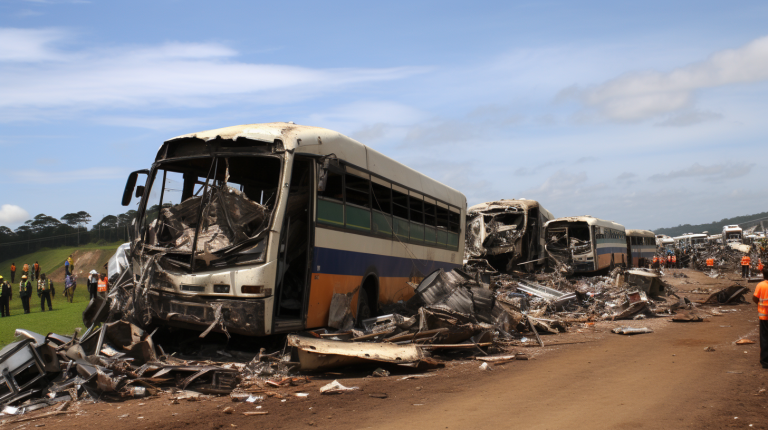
[464, 199, 555, 273]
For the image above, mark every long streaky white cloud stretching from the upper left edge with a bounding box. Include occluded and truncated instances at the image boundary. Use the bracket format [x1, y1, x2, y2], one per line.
[0, 29, 422, 118]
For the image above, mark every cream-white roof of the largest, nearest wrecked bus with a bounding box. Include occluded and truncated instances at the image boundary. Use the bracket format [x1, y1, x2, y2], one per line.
[164, 122, 467, 209]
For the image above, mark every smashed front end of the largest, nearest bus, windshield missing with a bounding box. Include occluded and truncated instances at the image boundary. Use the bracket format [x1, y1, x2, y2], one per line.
[124, 127, 287, 336]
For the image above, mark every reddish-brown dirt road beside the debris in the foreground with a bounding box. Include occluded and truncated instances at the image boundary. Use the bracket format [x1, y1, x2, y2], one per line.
[9, 270, 768, 430]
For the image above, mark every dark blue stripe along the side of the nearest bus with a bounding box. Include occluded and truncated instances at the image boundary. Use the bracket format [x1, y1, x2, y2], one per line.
[312, 247, 460, 278]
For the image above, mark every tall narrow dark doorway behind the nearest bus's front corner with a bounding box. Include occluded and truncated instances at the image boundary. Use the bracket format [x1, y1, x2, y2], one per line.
[273, 156, 315, 333]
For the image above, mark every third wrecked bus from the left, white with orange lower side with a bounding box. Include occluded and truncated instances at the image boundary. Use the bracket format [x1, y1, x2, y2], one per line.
[544, 215, 627, 273]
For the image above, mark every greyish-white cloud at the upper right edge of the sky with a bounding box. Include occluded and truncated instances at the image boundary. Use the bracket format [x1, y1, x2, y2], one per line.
[560, 36, 768, 121]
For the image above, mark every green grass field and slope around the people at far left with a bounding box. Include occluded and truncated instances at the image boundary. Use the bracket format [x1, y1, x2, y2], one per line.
[0, 243, 120, 347]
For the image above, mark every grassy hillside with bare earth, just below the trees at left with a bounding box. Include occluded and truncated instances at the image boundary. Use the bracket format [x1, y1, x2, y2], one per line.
[0, 242, 120, 284]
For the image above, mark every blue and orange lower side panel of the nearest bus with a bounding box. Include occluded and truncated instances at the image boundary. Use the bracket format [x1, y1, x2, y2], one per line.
[307, 247, 459, 328]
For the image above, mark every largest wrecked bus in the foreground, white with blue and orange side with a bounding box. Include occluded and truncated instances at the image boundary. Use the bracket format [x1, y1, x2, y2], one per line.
[123, 123, 466, 336]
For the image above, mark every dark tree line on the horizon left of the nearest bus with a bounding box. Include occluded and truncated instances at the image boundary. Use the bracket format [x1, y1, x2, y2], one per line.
[0, 210, 136, 261]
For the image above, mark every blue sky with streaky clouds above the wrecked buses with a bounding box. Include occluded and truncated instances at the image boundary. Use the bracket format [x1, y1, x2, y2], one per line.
[0, 0, 768, 232]
